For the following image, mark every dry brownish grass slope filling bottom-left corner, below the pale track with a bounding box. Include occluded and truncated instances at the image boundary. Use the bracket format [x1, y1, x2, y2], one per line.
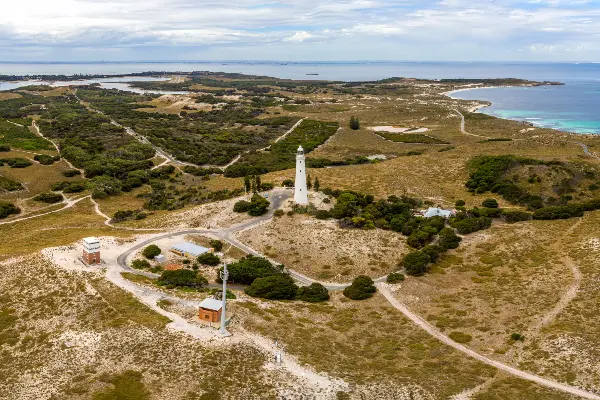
[0, 257, 288, 400]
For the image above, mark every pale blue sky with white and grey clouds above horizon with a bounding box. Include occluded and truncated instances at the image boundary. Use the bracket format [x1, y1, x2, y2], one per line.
[0, 0, 600, 61]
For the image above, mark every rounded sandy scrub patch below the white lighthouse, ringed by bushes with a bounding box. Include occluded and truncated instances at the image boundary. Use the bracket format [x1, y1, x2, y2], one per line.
[237, 215, 409, 282]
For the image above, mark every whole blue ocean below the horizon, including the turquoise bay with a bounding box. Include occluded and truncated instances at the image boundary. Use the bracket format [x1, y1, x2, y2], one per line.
[0, 61, 600, 134]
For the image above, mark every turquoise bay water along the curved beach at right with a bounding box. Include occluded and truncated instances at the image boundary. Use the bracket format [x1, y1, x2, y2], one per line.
[452, 80, 600, 134]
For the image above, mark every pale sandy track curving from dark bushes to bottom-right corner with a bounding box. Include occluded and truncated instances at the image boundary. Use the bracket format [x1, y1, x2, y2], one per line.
[377, 283, 600, 400]
